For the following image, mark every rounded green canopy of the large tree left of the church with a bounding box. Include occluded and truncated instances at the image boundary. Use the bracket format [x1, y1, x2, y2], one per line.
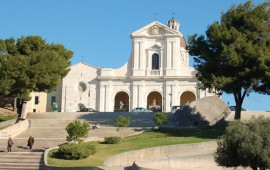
[0, 36, 73, 100]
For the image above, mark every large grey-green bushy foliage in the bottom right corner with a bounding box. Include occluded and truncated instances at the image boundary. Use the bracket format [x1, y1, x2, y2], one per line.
[215, 116, 270, 169]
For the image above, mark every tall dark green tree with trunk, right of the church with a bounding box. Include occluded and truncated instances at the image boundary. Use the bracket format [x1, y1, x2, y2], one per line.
[189, 1, 270, 119]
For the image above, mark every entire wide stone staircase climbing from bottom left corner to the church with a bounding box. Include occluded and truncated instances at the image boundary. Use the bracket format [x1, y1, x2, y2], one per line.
[0, 112, 162, 170]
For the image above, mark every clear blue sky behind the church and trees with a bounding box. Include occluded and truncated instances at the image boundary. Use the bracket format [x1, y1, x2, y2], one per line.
[0, 0, 270, 111]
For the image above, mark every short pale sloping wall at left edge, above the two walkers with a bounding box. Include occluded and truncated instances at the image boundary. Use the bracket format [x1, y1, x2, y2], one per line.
[0, 119, 29, 138]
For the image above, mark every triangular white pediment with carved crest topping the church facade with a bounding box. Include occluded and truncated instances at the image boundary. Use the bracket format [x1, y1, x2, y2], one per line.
[130, 21, 182, 37]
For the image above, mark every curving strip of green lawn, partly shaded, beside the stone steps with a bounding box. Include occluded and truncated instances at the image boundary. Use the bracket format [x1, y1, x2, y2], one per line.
[48, 127, 225, 167]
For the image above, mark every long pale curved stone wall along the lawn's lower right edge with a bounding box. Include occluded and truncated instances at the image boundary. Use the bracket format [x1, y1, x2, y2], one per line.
[104, 141, 217, 167]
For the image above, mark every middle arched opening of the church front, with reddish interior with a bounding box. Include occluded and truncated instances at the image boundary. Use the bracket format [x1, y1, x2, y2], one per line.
[147, 91, 162, 111]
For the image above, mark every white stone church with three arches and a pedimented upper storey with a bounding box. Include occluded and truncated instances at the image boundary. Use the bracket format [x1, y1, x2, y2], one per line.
[26, 18, 214, 112]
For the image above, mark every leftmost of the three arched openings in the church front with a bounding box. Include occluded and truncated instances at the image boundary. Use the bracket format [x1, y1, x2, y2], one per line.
[114, 91, 129, 112]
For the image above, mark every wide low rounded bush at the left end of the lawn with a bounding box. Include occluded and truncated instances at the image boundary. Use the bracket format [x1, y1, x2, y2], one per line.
[55, 143, 97, 159]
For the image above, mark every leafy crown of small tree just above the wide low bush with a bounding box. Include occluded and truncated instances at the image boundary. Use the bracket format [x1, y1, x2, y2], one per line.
[66, 120, 90, 142]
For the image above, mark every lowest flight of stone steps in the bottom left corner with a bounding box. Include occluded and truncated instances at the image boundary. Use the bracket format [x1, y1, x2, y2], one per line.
[0, 152, 45, 170]
